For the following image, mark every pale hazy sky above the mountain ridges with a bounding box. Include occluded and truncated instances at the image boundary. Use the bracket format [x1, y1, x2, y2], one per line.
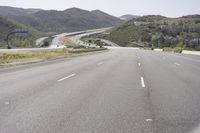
[0, 0, 200, 17]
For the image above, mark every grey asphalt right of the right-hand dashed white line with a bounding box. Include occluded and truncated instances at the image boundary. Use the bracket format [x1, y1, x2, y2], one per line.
[138, 52, 200, 133]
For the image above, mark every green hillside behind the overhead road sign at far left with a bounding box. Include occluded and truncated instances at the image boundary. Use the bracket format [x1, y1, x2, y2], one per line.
[0, 17, 43, 48]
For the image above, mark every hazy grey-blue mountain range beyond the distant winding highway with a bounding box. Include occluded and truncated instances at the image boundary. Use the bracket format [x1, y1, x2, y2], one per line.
[0, 7, 123, 32]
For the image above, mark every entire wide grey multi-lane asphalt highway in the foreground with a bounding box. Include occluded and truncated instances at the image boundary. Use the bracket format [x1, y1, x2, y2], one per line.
[0, 47, 200, 133]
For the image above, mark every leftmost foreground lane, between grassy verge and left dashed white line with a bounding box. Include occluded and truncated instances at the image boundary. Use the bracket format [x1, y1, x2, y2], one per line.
[0, 52, 113, 105]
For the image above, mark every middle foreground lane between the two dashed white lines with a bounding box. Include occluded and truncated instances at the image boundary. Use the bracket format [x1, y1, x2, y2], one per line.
[0, 50, 152, 133]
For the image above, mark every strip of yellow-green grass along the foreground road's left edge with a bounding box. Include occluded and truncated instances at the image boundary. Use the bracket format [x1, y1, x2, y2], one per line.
[0, 48, 106, 66]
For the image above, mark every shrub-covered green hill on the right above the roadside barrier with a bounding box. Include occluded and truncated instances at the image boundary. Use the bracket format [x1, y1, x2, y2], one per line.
[98, 15, 200, 50]
